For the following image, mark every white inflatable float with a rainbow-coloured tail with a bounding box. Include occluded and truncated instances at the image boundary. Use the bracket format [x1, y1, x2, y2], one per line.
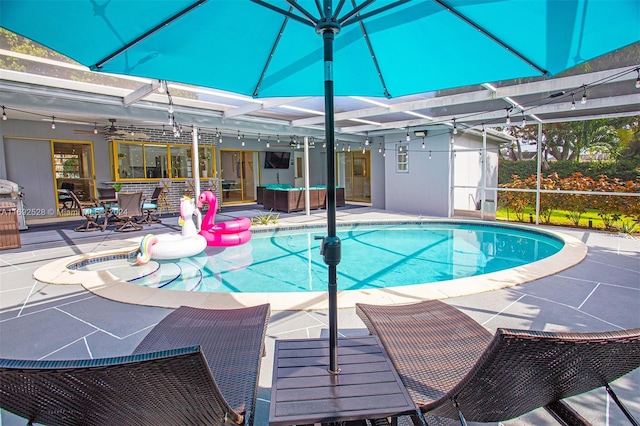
[136, 196, 207, 265]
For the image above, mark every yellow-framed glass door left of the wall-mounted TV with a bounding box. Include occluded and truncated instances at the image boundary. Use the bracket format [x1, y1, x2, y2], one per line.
[220, 150, 258, 204]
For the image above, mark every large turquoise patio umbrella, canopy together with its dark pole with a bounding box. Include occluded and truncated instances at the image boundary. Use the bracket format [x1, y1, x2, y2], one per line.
[0, 0, 640, 372]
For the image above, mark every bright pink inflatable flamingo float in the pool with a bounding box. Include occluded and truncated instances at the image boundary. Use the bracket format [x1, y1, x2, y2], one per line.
[198, 191, 251, 247]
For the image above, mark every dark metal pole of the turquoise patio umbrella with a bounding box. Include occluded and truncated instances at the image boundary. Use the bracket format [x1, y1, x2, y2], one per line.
[319, 24, 341, 374]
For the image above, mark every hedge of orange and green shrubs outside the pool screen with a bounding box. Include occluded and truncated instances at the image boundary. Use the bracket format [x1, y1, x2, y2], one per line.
[498, 173, 640, 229]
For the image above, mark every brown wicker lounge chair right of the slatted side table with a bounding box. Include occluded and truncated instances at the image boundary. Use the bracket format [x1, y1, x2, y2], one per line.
[356, 300, 640, 424]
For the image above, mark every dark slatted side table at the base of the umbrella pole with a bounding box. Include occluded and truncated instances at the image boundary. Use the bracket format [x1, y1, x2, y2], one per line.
[269, 336, 418, 426]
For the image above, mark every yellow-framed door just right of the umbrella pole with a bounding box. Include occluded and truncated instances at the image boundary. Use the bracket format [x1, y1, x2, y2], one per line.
[338, 150, 371, 203]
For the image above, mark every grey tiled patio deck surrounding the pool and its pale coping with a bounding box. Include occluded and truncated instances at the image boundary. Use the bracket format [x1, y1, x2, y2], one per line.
[0, 206, 640, 425]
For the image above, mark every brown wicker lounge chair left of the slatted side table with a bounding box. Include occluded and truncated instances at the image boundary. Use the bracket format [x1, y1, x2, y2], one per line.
[0, 305, 269, 425]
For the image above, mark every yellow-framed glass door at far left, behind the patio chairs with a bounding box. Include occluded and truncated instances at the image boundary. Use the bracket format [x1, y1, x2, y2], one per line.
[52, 141, 96, 216]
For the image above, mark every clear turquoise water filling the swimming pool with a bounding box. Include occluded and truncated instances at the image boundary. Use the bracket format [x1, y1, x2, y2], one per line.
[81, 223, 564, 293]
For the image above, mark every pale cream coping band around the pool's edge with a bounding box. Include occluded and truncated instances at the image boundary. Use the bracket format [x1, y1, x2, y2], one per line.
[33, 219, 587, 311]
